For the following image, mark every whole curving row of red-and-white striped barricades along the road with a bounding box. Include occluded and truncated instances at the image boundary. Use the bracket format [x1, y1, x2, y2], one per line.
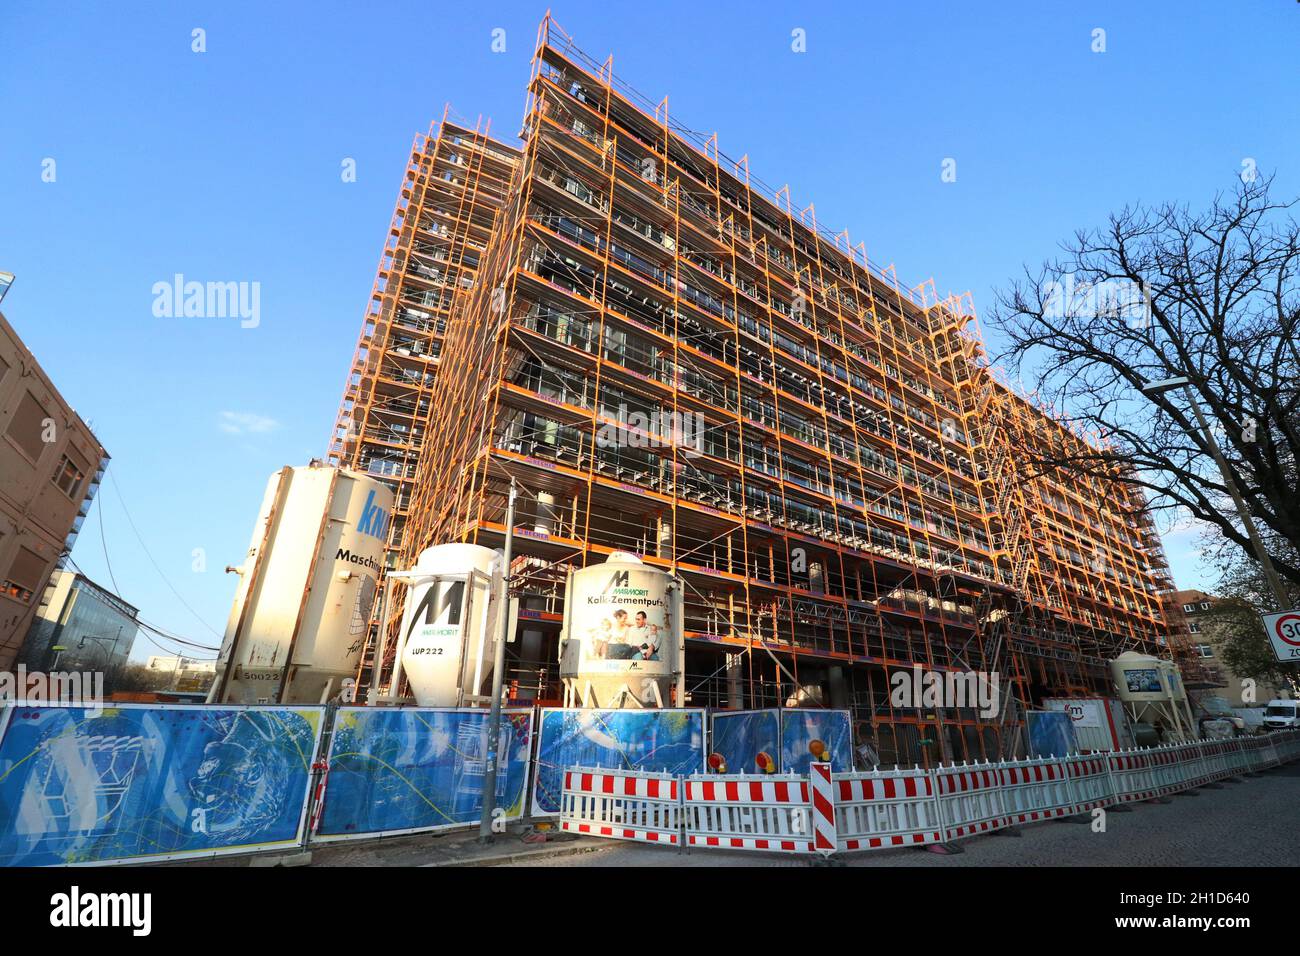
[560, 730, 1300, 856]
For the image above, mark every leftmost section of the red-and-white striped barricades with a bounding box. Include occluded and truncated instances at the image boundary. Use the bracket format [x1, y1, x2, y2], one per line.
[560, 767, 681, 847]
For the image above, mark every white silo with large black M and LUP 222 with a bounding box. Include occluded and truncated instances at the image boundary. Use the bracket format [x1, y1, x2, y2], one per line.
[398, 544, 502, 708]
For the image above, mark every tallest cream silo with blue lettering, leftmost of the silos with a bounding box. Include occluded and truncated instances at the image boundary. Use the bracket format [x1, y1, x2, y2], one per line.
[209, 464, 393, 704]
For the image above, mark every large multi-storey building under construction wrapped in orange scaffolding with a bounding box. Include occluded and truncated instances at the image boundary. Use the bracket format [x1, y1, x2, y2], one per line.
[343, 17, 1196, 763]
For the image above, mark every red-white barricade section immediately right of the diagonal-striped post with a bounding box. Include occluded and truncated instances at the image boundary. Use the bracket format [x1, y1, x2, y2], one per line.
[835, 767, 944, 851]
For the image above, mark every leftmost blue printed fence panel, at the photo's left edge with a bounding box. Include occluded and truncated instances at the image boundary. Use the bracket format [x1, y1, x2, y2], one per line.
[0, 704, 324, 866]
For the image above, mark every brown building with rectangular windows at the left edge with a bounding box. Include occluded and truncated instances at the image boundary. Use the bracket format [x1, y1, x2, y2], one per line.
[0, 315, 108, 670]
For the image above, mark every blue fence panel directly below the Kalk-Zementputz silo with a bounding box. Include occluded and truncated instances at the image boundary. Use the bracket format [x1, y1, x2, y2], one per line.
[533, 708, 705, 817]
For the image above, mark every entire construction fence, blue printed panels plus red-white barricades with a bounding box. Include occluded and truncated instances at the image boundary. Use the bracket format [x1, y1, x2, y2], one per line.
[0, 704, 1300, 866]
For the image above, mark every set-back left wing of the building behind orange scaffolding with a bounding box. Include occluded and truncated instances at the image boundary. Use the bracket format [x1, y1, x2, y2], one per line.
[329, 111, 519, 681]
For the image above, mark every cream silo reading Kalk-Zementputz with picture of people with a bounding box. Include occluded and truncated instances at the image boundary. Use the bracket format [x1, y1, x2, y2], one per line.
[560, 551, 683, 708]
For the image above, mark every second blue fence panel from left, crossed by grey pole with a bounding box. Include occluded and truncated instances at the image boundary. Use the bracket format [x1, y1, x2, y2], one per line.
[312, 708, 533, 843]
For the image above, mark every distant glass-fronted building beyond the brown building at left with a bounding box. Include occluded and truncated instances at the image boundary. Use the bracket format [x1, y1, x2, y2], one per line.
[18, 570, 139, 691]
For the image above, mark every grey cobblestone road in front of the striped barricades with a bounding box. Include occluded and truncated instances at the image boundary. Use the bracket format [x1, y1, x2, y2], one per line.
[496, 761, 1300, 866]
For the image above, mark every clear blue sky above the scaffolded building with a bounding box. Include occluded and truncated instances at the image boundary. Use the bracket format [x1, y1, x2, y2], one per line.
[0, 0, 1300, 657]
